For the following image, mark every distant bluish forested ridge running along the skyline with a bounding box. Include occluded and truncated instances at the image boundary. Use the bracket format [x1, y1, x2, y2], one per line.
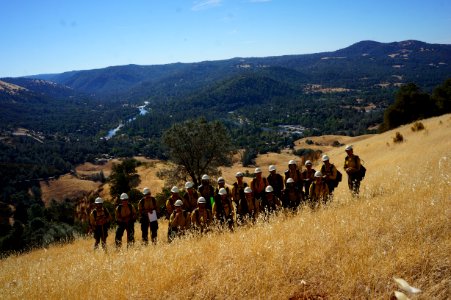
[33, 41, 451, 98]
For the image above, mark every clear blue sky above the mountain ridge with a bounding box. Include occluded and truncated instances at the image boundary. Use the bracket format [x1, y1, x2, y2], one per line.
[0, 0, 451, 77]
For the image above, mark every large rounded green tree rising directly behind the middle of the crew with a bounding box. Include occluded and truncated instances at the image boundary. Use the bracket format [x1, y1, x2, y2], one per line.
[163, 119, 233, 185]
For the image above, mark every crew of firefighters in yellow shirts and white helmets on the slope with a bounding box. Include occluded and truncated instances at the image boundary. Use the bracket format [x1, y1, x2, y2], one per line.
[90, 145, 365, 249]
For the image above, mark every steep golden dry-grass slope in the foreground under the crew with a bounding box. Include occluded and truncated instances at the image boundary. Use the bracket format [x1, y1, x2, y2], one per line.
[0, 115, 451, 299]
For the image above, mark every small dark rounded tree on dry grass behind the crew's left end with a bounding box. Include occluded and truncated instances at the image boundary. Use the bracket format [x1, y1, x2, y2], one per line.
[109, 158, 140, 199]
